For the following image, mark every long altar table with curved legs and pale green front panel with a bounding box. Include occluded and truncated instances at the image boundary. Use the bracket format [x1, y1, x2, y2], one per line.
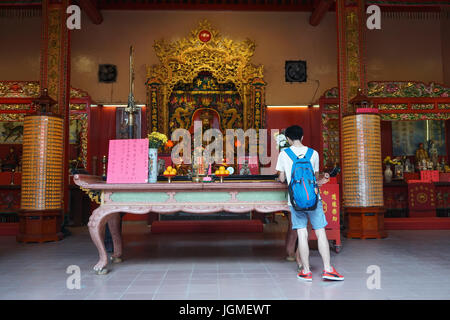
[74, 175, 340, 274]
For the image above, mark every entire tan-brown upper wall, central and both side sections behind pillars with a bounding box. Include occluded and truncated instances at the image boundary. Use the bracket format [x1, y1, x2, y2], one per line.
[0, 11, 444, 105]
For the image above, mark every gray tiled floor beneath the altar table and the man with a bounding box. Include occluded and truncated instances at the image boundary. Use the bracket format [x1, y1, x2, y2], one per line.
[0, 223, 450, 300]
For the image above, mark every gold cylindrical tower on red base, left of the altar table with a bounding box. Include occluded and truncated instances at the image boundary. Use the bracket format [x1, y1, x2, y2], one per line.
[16, 115, 64, 242]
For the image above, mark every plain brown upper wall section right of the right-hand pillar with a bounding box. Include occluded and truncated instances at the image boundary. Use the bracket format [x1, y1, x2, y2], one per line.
[367, 15, 443, 83]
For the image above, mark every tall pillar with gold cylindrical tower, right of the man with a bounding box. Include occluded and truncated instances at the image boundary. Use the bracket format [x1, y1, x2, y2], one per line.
[336, 0, 385, 238]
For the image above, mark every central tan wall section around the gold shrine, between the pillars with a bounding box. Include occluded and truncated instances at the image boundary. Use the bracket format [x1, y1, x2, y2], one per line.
[72, 11, 337, 104]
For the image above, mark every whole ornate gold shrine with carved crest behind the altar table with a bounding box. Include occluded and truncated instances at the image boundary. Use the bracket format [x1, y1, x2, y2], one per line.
[146, 20, 266, 136]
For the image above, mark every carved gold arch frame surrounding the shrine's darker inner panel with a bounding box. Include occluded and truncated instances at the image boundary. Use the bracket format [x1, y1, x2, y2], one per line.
[147, 20, 265, 134]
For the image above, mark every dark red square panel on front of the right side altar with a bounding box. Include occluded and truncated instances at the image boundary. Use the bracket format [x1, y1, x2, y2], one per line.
[408, 182, 436, 217]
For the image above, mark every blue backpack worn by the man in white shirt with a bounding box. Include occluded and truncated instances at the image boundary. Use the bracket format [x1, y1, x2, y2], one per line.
[284, 148, 319, 211]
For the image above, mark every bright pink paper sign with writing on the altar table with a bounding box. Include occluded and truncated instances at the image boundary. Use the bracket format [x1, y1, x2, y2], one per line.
[106, 139, 148, 183]
